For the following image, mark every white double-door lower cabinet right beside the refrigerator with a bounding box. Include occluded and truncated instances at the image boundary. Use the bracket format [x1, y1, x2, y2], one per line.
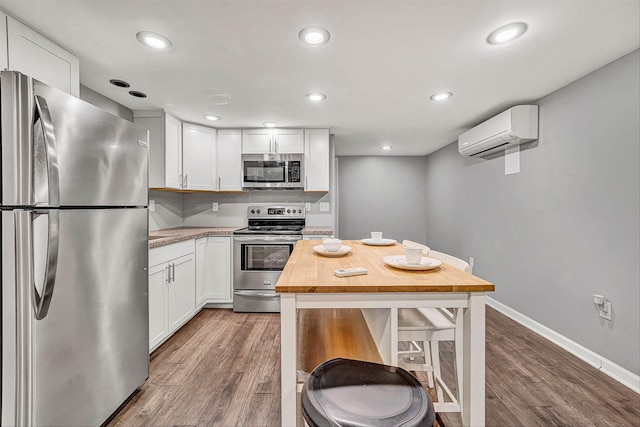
[149, 240, 196, 352]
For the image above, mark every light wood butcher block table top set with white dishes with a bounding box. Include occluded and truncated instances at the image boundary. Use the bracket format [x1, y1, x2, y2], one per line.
[276, 240, 495, 293]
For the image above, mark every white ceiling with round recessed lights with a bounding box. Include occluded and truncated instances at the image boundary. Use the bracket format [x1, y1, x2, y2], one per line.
[0, 0, 640, 155]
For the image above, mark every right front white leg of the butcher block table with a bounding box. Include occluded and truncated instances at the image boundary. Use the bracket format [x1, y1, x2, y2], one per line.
[462, 293, 485, 427]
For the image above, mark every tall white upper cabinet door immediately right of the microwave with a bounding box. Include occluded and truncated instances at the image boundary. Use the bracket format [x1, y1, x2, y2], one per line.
[304, 129, 330, 191]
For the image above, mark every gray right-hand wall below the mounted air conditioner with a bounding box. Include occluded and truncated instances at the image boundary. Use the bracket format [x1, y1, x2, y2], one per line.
[426, 51, 640, 374]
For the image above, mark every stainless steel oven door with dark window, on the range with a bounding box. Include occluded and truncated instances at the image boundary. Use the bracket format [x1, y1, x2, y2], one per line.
[233, 235, 302, 290]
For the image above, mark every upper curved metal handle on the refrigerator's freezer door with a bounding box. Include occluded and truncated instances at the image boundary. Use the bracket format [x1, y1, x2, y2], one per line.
[33, 95, 60, 207]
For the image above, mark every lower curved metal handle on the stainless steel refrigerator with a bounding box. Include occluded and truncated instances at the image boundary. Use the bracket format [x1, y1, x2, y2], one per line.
[31, 209, 60, 320]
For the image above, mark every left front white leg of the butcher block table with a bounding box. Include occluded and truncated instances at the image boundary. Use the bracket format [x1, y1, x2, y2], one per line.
[280, 294, 298, 427]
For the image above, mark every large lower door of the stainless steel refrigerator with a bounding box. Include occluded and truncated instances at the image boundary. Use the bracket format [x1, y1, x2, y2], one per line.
[2, 209, 149, 426]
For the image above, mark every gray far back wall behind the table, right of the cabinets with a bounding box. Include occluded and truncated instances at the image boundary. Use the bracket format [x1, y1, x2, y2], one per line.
[338, 156, 427, 242]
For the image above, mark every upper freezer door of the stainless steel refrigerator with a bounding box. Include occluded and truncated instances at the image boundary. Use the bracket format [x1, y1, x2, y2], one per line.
[0, 71, 148, 207]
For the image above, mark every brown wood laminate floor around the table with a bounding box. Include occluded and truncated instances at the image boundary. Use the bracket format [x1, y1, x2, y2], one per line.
[107, 308, 640, 427]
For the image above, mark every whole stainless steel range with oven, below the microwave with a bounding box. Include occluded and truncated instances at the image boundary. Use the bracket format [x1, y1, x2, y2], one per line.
[233, 205, 305, 313]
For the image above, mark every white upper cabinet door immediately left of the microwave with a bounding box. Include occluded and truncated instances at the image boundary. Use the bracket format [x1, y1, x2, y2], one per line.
[216, 129, 242, 191]
